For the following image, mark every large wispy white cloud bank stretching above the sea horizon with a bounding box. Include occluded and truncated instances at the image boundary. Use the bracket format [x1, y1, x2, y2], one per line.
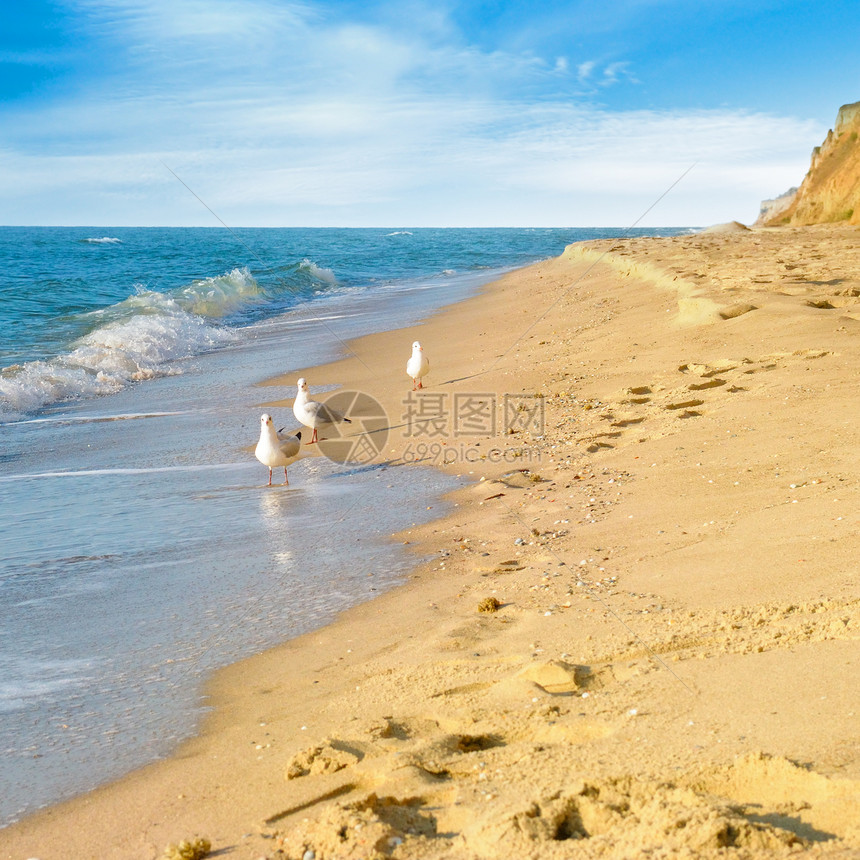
[0, 0, 825, 226]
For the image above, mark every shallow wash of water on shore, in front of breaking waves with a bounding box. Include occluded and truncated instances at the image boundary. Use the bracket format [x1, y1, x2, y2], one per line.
[0, 270, 478, 823]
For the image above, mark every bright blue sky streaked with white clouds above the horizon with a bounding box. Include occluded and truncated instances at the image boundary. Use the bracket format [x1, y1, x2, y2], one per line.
[0, 0, 860, 227]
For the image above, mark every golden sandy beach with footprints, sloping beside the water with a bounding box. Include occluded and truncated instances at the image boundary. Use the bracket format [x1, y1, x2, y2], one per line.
[0, 227, 860, 860]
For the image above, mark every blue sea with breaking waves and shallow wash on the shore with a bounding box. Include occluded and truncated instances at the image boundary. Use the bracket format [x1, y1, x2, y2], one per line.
[0, 227, 689, 827]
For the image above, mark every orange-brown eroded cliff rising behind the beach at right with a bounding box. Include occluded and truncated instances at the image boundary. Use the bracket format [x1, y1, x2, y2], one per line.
[756, 102, 860, 227]
